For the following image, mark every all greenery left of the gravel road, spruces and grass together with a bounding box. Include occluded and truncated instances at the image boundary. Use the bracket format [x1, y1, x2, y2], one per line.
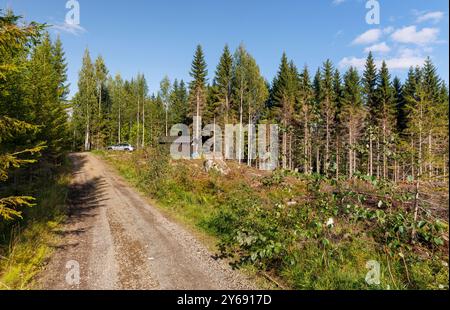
[0, 12, 70, 289]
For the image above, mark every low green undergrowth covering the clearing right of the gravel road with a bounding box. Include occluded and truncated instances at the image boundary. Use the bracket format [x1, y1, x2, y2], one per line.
[101, 149, 448, 289]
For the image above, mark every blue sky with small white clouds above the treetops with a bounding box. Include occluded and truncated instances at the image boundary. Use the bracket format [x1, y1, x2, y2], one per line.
[0, 0, 449, 95]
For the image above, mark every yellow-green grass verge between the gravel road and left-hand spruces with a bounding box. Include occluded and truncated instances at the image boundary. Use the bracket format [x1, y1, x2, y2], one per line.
[0, 163, 70, 290]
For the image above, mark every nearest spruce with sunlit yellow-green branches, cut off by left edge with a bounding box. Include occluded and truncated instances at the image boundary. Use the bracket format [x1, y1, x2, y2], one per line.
[0, 11, 43, 220]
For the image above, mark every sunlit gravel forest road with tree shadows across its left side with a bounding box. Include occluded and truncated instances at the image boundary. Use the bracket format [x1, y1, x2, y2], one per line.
[38, 153, 255, 290]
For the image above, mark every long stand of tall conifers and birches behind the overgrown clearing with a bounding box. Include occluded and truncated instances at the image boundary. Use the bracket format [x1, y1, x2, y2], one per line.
[73, 45, 448, 186]
